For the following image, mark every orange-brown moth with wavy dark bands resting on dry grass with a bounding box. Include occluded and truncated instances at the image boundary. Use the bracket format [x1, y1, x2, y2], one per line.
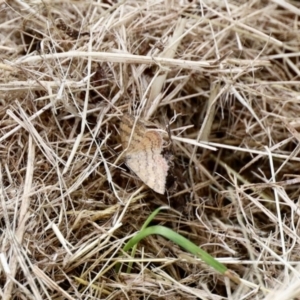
[120, 114, 169, 194]
